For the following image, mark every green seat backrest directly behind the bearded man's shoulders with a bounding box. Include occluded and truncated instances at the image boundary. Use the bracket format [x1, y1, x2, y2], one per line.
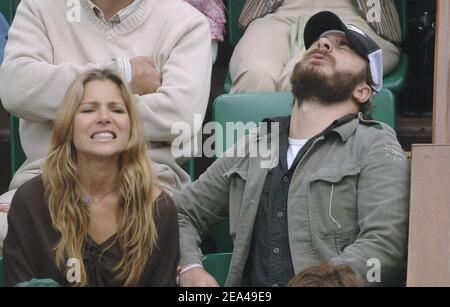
[213, 89, 396, 156]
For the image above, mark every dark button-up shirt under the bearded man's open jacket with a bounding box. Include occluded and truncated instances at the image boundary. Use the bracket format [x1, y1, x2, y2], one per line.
[244, 114, 355, 287]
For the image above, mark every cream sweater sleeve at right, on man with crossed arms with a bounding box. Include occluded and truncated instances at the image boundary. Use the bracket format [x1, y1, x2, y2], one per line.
[135, 16, 212, 142]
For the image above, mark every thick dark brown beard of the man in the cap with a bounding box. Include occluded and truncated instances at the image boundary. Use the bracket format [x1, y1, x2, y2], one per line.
[291, 57, 366, 106]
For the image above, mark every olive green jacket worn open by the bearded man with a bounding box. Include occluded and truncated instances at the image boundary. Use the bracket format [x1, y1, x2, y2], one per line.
[174, 114, 410, 286]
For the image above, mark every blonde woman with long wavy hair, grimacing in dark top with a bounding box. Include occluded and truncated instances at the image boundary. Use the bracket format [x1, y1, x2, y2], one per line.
[4, 70, 179, 286]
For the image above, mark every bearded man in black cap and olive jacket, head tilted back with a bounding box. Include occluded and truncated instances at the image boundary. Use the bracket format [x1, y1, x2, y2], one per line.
[174, 12, 410, 286]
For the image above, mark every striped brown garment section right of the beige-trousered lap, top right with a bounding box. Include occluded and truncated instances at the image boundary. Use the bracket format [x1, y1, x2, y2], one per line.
[357, 0, 402, 44]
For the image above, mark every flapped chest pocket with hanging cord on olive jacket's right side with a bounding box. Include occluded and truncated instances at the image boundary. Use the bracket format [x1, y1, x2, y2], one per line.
[308, 164, 361, 239]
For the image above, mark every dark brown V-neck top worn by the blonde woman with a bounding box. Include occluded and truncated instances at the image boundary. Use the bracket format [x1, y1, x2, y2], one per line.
[3, 176, 180, 287]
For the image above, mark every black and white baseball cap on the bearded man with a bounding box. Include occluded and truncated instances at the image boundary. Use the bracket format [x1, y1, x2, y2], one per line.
[303, 11, 383, 92]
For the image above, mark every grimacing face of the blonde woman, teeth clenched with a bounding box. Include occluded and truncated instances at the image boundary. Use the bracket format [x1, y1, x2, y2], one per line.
[73, 80, 131, 159]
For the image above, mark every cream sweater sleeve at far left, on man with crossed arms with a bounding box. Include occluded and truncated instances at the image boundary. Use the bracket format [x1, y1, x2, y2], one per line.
[0, 1, 111, 121]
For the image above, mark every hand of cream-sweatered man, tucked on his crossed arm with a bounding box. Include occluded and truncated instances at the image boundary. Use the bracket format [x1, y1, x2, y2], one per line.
[130, 56, 161, 95]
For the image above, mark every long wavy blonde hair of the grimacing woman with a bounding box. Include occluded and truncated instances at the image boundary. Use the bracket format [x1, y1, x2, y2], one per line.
[42, 70, 157, 286]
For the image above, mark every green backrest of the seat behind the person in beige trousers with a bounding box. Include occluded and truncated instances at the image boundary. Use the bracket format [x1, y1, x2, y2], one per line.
[226, 0, 408, 47]
